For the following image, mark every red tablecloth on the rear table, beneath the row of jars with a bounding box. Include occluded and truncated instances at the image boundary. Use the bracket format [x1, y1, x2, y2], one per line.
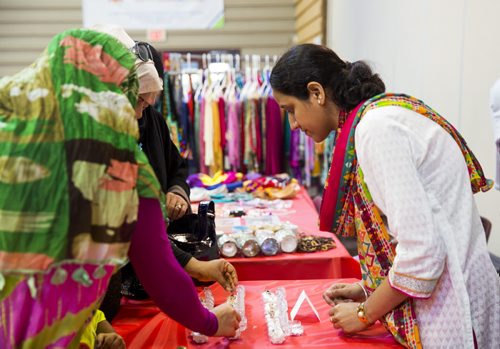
[220, 188, 361, 281]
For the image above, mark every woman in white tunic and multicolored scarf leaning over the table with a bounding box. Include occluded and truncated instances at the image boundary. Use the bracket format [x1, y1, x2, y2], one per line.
[271, 44, 500, 348]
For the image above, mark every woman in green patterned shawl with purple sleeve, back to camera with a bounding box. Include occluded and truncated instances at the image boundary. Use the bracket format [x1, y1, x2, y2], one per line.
[0, 30, 238, 348]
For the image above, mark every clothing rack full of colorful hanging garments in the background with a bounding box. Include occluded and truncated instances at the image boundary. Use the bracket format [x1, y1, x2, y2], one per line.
[160, 52, 327, 185]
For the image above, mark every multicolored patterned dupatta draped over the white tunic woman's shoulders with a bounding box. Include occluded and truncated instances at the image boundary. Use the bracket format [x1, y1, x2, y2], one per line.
[320, 93, 493, 348]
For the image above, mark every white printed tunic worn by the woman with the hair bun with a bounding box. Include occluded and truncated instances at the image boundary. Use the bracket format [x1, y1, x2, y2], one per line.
[355, 106, 500, 348]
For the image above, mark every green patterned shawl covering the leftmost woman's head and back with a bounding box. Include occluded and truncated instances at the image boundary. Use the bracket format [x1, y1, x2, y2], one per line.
[0, 29, 163, 272]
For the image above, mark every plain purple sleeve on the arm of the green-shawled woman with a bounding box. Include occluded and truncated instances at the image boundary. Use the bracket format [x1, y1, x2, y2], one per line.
[129, 198, 218, 336]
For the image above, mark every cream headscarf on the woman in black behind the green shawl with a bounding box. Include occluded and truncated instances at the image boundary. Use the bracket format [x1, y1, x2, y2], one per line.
[91, 25, 163, 94]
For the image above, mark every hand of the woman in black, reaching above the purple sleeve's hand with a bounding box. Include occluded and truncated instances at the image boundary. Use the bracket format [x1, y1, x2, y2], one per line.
[185, 258, 238, 292]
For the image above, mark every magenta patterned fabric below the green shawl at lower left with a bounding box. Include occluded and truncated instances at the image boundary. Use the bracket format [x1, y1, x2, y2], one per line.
[0, 263, 114, 348]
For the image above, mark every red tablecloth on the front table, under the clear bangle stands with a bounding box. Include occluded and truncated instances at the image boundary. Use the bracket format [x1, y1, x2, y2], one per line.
[113, 279, 400, 349]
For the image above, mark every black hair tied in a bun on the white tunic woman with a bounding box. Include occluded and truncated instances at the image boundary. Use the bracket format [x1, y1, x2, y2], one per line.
[270, 44, 385, 111]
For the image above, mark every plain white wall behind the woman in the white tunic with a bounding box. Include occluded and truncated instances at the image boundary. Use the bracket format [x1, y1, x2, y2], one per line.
[327, 0, 500, 255]
